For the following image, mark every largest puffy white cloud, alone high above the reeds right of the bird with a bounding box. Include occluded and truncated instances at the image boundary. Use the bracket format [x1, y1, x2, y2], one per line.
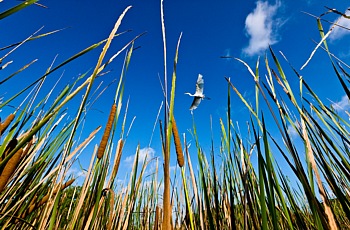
[243, 0, 283, 56]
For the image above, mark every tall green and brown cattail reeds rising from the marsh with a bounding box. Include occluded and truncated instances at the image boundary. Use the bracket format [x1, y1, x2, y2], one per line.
[0, 0, 350, 230]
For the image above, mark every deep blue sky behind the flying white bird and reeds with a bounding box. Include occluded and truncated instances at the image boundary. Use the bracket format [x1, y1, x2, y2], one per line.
[0, 0, 350, 183]
